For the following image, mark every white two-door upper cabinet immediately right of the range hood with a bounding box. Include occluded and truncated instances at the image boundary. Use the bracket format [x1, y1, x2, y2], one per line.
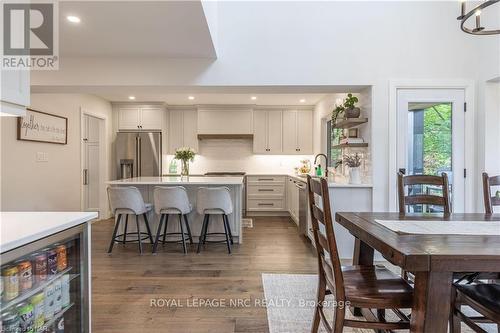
[253, 110, 282, 154]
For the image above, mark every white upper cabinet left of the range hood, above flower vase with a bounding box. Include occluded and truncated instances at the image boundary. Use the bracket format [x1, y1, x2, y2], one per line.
[168, 110, 198, 154]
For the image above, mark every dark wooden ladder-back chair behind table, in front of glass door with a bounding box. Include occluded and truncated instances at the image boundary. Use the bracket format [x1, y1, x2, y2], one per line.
[398, 172, 451, 216]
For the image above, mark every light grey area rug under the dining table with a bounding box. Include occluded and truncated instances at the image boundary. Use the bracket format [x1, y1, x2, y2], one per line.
[262, 274, 497, 333]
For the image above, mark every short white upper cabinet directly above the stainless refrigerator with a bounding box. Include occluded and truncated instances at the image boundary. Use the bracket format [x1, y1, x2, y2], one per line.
[118, 106, 164, 131]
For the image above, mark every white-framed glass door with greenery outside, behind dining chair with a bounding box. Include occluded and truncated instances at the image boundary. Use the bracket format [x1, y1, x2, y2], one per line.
[394, 89, 466, 213]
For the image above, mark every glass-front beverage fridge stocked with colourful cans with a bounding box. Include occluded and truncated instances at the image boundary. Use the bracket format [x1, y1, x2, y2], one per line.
[0, 224, 90, 333]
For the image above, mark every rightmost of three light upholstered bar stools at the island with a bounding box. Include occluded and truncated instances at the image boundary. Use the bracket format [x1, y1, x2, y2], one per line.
[196, 187, 234, 254]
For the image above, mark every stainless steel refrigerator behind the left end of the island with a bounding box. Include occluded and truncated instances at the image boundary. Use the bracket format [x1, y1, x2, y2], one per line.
[115, 132, 161, 179]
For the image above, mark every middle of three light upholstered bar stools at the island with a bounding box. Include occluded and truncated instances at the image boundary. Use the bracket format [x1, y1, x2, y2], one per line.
[153, 186, 193, 253]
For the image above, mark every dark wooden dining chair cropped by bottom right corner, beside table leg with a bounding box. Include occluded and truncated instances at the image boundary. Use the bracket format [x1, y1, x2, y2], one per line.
[450, 283, 500, 333]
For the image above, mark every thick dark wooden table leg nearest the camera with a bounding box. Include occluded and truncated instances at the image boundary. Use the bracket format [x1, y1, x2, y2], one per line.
[410, 272, 453, 333]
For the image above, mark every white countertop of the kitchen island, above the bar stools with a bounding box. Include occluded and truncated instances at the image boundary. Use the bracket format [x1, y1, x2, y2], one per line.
[107, 176, 243, 186]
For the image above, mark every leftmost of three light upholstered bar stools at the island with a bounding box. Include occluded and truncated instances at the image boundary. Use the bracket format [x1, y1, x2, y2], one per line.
[108, 186, 153, 254]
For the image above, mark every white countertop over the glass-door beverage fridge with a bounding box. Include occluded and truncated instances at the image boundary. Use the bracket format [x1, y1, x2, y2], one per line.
[0, 212, 97, 253]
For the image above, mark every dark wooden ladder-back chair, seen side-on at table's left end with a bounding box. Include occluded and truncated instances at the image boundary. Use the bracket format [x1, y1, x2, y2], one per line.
[307, 176, 413, 333]
